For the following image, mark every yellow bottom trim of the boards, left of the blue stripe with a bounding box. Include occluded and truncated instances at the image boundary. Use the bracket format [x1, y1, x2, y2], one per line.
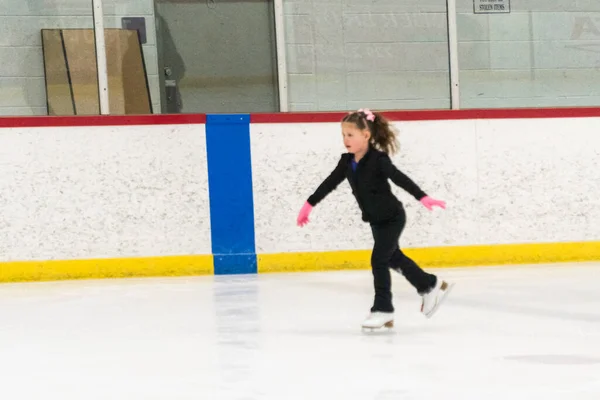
[0, 255, 214, 282]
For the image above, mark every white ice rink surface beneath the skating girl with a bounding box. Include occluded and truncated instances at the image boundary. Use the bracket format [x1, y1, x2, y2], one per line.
[0, 264, 600, 400]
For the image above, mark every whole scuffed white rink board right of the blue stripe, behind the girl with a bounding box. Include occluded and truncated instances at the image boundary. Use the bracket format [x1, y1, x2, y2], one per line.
[251, 118, 600, 254]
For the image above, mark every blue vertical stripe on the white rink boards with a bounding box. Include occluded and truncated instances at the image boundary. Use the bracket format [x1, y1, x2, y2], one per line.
[206, 114, 257, 275]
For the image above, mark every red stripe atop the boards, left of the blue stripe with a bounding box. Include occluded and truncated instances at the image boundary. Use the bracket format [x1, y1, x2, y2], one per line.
[0, 114, 206, 128]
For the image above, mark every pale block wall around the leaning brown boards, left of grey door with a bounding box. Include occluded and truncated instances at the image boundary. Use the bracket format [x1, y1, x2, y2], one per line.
[0, 0, 160, 115]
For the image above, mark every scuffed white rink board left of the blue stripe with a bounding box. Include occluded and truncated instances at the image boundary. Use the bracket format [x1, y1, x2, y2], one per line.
[0, 125, 211, 261]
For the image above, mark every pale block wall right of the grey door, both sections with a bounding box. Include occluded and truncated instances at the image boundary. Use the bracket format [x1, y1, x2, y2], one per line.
[284, 0, 600, 111]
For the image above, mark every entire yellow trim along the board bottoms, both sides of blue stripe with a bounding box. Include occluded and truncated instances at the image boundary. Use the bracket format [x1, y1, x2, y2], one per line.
[0, 242, 600, 282]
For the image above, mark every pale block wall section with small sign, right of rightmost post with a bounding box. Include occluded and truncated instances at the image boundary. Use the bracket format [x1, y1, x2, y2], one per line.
[457, 0, 600, 108]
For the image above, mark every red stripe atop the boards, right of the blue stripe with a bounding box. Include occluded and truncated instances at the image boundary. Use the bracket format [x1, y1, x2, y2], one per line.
[250, 107, 600, 123]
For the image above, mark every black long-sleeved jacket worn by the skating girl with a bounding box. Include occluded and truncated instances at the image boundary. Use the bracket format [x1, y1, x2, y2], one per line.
[307, 146, 427, 224]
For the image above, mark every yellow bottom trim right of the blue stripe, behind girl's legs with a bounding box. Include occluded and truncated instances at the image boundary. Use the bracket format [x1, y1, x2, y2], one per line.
[257, 242, 600, 273]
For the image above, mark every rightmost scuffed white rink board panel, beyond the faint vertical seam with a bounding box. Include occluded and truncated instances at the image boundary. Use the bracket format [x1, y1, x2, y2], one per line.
[477, 118, 600, 243]
